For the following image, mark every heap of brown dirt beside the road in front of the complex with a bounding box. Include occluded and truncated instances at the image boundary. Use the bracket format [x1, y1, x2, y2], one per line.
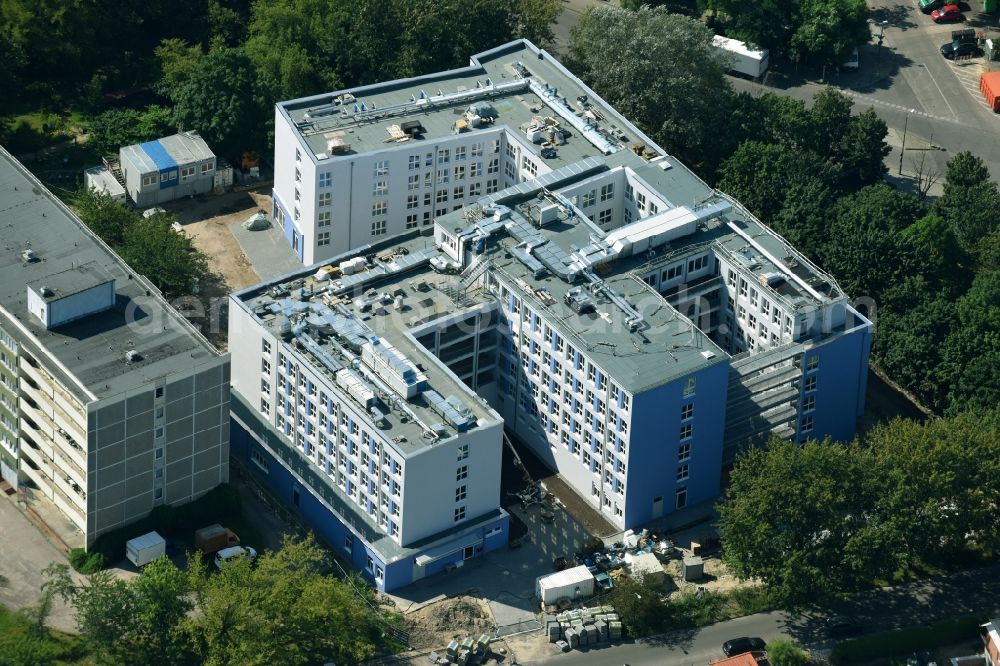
[404, 596, 493, 650]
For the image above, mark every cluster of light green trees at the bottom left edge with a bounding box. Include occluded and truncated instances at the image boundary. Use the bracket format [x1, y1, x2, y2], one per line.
[46, 539, 384, 666]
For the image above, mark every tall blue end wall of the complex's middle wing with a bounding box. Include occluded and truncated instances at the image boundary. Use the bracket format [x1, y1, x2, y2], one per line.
[625, 361, 729, 527]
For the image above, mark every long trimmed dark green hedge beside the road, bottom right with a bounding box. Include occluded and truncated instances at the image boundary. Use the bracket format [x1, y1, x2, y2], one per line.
[830, 614, 989, 666]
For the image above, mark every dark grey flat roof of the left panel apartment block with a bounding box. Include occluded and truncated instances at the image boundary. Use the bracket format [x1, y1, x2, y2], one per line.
[0, 148, 219, 403]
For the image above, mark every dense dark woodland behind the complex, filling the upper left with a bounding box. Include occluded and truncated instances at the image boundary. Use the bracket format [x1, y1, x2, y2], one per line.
[0, 0, 559, 159]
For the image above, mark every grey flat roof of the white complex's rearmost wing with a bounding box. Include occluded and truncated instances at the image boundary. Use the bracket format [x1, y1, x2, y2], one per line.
[278, 40, 658, 168]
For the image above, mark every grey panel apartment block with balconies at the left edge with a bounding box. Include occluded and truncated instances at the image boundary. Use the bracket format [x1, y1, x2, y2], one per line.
[0, 144, 229, 547]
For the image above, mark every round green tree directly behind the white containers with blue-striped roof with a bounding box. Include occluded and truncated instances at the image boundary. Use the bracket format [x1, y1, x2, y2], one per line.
[173, 47, 270, 157]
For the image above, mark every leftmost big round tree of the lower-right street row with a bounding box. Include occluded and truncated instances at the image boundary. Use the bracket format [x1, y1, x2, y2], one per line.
[718, 439, 896, 604]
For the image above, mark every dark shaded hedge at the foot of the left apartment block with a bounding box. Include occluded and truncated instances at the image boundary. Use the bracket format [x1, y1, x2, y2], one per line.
[90, 483, 241, 570]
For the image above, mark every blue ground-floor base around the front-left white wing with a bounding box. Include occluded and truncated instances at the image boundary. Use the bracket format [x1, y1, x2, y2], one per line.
[230, 412, 509, 592]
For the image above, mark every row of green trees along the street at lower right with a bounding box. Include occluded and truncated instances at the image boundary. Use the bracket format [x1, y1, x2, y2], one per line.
[719, 405, 1000, 603]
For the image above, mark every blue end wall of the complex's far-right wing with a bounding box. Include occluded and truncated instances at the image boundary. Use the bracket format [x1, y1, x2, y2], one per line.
[798, 326, 871, 442]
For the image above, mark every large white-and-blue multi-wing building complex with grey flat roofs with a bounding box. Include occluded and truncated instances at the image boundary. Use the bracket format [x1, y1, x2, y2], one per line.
[248, 41, 872, 589]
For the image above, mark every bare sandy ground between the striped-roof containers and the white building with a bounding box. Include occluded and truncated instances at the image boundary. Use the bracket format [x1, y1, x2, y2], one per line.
[163, 186, 271, 350]
